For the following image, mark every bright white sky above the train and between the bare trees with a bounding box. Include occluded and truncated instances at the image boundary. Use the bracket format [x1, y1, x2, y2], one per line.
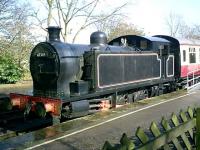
[30, 0, 200, 44]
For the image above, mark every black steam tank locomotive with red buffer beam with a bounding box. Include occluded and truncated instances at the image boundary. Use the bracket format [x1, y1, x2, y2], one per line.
[6, 27, 180, 118]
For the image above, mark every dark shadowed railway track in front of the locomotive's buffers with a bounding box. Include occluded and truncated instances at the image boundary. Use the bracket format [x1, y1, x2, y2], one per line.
[0, 111, 53, 141]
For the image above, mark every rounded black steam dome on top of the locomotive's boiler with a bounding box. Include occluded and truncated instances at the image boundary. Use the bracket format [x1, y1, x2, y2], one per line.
[90, 31, 107, 46]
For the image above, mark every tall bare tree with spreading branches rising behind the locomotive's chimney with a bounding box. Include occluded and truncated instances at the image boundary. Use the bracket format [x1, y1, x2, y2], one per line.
[35, 0, 127, 43]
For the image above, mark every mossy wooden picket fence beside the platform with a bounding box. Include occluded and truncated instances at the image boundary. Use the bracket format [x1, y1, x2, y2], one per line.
[102, 107, 200, 150]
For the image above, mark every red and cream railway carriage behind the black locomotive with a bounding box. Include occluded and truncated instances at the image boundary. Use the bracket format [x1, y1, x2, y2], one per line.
[179, 39, 200, 78]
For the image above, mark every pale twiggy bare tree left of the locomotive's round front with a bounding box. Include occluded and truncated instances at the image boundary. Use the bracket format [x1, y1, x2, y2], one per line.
[0, 1, 34, 67]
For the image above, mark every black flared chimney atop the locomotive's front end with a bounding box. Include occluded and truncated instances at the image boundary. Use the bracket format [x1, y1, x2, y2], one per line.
[47, 26, 61, 42]
